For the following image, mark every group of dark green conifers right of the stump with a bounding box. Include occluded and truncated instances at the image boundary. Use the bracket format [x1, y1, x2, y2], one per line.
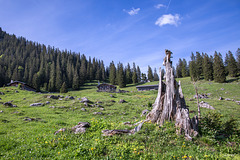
[175, 48, 240, 83]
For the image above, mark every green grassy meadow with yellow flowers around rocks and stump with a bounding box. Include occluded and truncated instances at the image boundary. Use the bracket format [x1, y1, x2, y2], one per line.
[0, 78, 240, 159]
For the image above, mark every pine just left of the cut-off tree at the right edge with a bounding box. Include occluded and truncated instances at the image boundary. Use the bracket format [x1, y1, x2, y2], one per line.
[227, 51, 238, 77]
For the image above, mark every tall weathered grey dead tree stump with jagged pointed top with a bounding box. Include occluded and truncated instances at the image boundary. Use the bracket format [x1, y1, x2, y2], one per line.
[147, 50, 198, 140]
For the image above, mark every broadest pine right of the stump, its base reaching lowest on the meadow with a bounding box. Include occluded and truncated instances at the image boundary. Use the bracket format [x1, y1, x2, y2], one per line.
[213, 52, 226, 83]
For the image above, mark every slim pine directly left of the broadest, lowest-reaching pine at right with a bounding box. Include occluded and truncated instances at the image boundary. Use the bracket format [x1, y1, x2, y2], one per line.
[203, 53, 213, 81]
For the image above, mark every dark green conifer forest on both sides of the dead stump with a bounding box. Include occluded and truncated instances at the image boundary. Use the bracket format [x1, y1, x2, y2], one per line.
[0, 28, 240, 92]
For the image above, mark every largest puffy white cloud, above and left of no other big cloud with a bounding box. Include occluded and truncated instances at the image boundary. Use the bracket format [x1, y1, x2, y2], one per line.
[155, 14, 180, 27]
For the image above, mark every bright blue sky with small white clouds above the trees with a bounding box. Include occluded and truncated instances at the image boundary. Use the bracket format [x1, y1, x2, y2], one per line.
[0, 0, 240, 72]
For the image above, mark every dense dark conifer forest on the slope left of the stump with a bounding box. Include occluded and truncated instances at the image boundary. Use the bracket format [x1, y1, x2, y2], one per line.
[0, 28, 146, 92]
